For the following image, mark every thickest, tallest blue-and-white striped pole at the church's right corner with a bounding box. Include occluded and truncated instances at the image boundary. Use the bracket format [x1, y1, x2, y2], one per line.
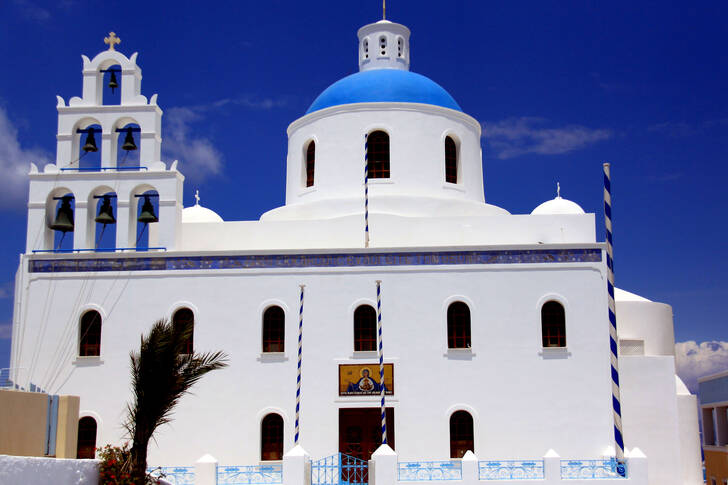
[604, 163, 624, 475]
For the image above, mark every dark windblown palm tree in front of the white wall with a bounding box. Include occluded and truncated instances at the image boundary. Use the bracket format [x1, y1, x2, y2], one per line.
[124, 320, 227, 484]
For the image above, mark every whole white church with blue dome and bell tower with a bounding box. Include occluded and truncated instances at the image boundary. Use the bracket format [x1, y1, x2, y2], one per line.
[10, 20, 702, 485]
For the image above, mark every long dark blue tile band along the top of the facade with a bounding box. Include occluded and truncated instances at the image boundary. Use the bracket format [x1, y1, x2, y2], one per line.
[28, 248, 602, 273]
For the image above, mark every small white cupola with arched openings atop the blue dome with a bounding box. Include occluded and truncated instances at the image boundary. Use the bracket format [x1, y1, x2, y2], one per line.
[357, 20, 410, 71]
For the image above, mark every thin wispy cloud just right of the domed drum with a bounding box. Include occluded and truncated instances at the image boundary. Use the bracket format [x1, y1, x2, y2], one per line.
[484, 116, 612, 160]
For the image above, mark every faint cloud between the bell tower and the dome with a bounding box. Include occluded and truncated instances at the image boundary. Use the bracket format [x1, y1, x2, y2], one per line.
[162, 108, 223, 181]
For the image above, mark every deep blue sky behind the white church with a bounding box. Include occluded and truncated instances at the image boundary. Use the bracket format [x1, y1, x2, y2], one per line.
[0, 0, 728, 367]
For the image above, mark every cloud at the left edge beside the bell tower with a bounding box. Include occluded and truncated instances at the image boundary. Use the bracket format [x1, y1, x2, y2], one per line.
[0, 106, 50, 209]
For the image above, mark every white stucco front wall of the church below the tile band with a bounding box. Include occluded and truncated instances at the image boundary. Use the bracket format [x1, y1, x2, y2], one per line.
[13, 253, 612, 465]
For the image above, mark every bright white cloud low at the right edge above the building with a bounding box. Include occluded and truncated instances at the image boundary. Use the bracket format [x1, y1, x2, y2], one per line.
[675, 340, 728, 393]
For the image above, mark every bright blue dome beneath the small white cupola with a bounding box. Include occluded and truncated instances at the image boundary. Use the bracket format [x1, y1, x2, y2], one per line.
[306, 69, 462, 114]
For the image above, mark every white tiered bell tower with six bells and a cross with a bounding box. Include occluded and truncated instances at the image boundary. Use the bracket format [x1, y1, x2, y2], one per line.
[26, 32, 184, 253]
